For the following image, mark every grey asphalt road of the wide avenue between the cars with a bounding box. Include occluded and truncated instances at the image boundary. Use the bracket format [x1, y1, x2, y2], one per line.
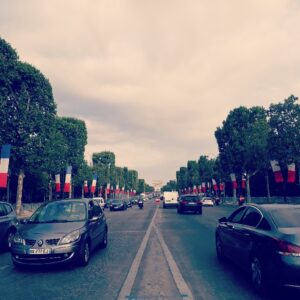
[0, 202, 300, 300]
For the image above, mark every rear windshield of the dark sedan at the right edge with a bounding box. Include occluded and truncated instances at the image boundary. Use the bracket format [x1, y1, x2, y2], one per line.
[271, 207, 300, 228]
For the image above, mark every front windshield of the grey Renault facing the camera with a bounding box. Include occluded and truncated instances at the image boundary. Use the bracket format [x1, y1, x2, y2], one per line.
[29, 201, 86, 223]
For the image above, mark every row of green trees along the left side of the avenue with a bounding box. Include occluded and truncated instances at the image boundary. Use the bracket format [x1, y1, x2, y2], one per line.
[0, 38, 151, 211]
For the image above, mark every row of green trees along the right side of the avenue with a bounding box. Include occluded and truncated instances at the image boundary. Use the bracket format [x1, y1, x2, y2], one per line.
[164, 95, 300, 201]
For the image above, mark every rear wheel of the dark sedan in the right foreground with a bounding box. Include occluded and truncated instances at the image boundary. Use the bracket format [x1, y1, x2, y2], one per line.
[250, 255, 267, 293]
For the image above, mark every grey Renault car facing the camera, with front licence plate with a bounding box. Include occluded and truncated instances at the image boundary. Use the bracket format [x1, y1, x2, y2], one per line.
[11, 199, 108, 267]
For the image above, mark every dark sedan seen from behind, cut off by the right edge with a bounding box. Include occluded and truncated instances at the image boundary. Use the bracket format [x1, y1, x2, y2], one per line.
[215, 204, 300, 292]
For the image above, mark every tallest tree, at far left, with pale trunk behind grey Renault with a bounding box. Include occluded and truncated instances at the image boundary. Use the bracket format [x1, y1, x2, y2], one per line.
[0, 38, 56, 213]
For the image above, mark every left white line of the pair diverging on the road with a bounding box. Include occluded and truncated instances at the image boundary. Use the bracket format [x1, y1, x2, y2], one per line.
[118, 208, 158, 300]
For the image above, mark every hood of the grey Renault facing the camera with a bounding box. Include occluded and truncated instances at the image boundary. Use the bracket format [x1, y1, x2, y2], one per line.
[18, 222, 85, 239]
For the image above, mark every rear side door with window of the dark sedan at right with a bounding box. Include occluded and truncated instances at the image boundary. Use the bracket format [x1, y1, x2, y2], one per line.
[232, 206, 263, 267]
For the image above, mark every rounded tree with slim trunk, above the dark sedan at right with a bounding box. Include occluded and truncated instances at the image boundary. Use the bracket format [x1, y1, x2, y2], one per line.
[215, 107, 269, 201]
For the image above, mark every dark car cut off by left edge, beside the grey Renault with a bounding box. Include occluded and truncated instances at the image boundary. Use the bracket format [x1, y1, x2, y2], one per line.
[0, 201, 18, 250]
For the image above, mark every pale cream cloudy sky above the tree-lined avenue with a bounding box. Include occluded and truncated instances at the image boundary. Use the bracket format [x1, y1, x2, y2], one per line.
[0, 0, 300, 185]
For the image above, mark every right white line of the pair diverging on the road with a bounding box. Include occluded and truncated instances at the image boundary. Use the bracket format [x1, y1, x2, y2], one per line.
[153, 225, 194, 300]
